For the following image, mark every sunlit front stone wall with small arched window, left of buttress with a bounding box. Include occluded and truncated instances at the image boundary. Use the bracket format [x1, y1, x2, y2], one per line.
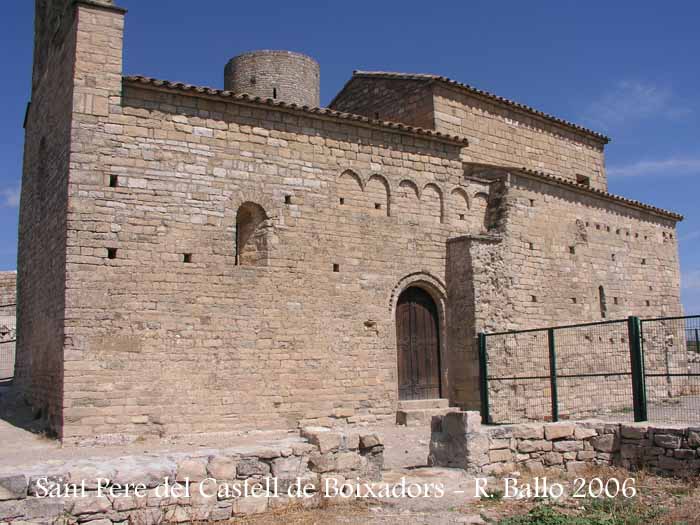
[50, 2, 504, 440]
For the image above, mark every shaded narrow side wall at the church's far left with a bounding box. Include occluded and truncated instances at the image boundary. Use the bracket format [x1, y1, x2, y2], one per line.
[15, 0, 85, 428]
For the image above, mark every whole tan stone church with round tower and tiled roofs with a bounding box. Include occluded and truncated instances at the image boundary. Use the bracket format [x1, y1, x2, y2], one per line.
[16, 0, 682, 442]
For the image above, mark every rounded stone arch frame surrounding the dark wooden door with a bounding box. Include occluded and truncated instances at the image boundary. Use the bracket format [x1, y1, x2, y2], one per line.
[391, 272, 450, 403]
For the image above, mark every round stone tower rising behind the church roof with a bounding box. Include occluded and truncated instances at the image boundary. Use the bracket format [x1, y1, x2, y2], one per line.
[224, 50, 321, 107]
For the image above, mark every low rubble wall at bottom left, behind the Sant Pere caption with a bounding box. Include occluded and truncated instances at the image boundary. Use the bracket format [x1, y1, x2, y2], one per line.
[0, 428, 384, 525]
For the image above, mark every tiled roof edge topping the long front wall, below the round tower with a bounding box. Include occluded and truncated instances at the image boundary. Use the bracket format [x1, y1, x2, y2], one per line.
[123, 76, 469, 146]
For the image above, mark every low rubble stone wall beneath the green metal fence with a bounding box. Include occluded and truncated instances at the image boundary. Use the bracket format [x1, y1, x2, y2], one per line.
[428, 412, 700, 476]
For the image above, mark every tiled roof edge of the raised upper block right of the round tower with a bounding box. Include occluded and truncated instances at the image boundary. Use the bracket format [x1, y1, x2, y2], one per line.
[348, 70, 610, 144]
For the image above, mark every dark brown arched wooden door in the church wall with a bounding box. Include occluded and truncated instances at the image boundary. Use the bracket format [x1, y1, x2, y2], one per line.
[396, 286, 441, 400]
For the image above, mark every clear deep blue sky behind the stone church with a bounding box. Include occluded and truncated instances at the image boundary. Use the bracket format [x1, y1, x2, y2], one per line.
[0, 0, 700, 313]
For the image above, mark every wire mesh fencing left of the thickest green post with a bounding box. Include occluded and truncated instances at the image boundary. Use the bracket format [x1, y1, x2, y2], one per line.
[481, 320, 633, 423]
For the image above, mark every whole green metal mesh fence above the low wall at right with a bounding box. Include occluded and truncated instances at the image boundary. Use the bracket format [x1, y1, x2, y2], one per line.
[479, 316, 700, 424]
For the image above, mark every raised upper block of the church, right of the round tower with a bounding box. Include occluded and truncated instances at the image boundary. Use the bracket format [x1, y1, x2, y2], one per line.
[331, 78, 607, 189]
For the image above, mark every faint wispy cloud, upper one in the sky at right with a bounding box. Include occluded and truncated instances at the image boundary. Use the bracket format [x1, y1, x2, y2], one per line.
[581, 81, 691, 130]
